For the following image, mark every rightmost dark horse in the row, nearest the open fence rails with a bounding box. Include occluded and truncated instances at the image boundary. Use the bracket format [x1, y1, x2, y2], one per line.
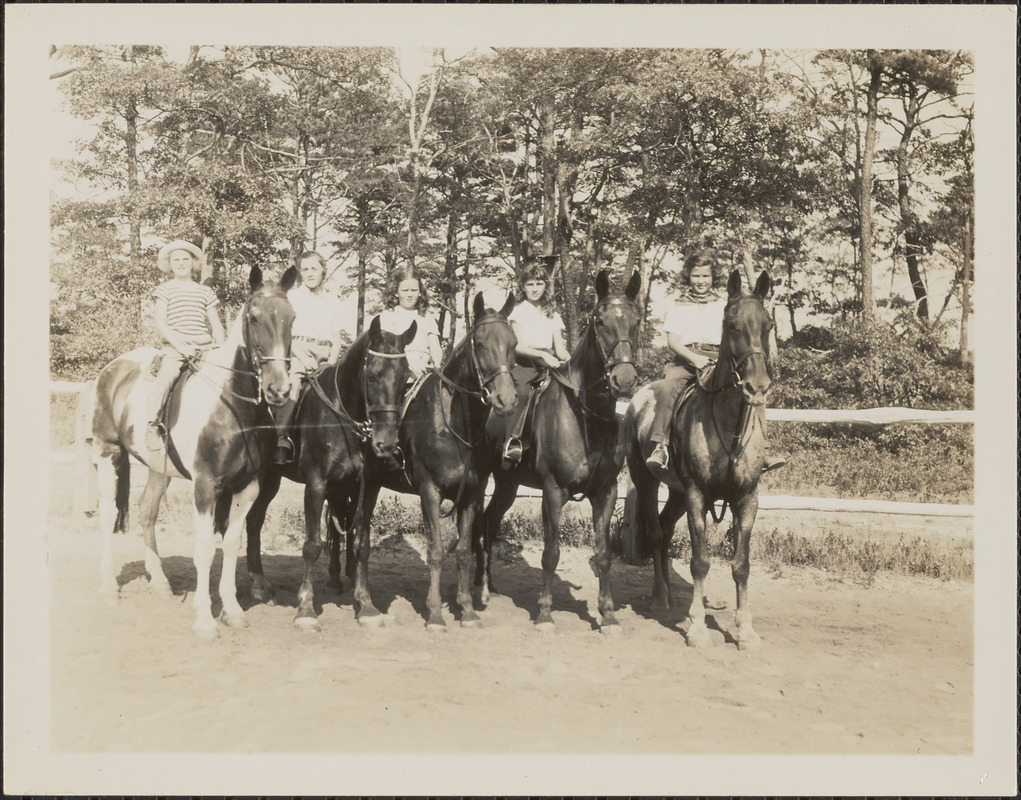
[624, 270, 773, 649]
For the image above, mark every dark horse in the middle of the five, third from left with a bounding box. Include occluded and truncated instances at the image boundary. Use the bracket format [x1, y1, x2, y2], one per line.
[330, 293, 517, 631]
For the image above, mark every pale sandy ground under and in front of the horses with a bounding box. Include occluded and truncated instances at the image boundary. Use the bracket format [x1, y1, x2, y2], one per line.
[48, 483, 973, 754]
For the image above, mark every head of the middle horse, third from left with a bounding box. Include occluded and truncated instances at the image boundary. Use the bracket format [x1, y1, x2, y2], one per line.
[468, 292, 518, 416]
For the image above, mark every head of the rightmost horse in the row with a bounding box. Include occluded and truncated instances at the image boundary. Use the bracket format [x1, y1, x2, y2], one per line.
[720, 269, 773, 405]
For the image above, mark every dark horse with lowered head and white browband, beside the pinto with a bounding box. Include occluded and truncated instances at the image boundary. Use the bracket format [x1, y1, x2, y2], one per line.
[248, 316, 418, 631]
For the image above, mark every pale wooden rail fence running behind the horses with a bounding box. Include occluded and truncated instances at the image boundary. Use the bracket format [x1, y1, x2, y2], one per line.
[50, 381, 975, 530]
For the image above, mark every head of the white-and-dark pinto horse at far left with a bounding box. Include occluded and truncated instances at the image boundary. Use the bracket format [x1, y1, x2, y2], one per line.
[241, 266, 297, 406]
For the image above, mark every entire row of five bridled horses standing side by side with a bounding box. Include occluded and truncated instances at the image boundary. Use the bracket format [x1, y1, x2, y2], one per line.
[93, 268, 771, 647]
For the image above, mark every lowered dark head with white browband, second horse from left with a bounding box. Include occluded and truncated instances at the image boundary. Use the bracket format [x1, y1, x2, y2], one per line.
[361, 316, 419, 460]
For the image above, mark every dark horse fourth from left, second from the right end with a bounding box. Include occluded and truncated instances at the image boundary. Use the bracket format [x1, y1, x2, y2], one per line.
[475, 270, 641, 633]
